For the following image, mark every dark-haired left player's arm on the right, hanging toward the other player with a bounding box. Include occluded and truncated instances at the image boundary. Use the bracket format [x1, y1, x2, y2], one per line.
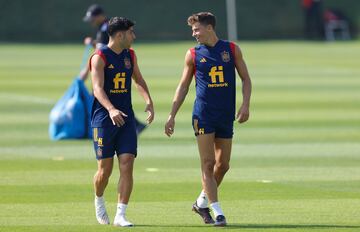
[132, 50, 154, 124]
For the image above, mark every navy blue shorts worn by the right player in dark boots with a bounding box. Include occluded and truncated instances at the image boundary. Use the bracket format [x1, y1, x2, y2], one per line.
[192, 116, 234, 139]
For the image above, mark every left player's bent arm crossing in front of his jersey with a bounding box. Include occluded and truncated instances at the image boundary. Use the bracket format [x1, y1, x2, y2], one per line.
[91, 54, 127, 126]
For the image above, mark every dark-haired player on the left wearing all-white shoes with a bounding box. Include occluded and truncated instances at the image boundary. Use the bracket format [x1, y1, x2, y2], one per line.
[89, 17, 154, 226]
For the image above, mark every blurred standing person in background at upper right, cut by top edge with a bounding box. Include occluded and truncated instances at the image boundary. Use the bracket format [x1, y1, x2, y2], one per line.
[302, 0, 324, 39]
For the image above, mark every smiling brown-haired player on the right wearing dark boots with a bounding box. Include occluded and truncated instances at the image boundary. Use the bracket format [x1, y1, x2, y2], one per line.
[165, 12, 251, 226]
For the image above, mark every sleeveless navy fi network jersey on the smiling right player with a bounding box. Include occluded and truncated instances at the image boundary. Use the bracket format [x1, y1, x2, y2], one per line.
[190, 40, 236, 122]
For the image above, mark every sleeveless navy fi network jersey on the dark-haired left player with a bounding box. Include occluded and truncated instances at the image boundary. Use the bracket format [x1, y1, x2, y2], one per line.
[90, 46, 134, 127]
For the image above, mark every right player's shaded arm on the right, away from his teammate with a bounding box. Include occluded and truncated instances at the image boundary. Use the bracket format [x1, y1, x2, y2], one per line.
[235, 45, 251, 123]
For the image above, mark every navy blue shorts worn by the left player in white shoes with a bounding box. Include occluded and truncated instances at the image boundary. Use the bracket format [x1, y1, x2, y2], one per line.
[93, 120, 137, 160]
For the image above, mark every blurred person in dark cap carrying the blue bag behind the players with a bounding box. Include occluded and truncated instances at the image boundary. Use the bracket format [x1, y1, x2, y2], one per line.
[79, 4, 146, 135]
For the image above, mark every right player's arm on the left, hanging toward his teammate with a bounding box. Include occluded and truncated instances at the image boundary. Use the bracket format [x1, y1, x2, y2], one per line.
[165, 50, 195, 137]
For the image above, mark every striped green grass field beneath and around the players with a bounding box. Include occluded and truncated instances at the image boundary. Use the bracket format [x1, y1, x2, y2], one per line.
[0, 41, 360, 231]
